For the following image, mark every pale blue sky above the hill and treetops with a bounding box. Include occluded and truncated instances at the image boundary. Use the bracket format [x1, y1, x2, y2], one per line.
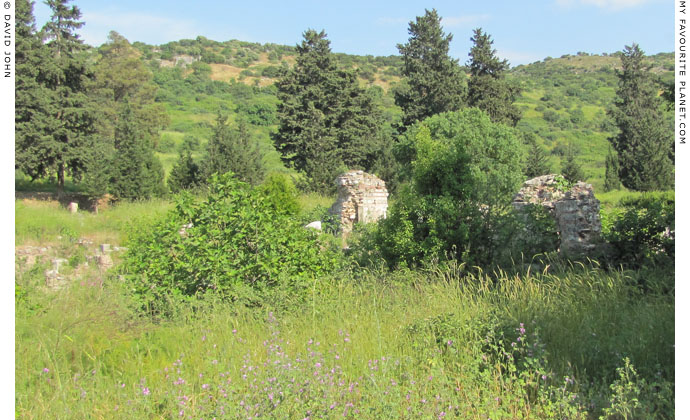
[34, 0, 673, 65]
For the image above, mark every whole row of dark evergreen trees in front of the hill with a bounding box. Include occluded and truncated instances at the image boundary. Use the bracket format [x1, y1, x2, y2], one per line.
[15, 0, 673, 199]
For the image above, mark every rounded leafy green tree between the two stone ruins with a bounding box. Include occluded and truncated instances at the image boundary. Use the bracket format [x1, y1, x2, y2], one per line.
[366, 108, 523, 267]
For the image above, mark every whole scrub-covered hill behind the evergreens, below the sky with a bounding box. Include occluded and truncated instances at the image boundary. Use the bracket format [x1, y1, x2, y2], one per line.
[126, 37, 673, 190]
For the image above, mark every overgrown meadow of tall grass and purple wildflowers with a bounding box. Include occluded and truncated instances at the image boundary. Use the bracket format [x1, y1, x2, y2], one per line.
[15, 188, 675, 419]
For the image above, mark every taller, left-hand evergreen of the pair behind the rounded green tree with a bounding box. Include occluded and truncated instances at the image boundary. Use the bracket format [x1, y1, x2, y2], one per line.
[394, 9, 466, 132]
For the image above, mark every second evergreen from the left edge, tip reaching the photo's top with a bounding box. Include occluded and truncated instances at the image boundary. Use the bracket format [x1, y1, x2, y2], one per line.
[16, 0, 96, 193]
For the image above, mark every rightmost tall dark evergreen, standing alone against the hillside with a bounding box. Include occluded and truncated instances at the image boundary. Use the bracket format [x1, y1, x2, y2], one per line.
[609, 44, 674, 191]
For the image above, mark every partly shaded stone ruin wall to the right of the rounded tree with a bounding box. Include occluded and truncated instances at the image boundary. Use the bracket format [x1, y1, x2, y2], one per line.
[513, 175, 601, 255]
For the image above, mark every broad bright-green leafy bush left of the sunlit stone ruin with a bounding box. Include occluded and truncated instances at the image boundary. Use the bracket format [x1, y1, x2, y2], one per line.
[122, 174, 337, 314]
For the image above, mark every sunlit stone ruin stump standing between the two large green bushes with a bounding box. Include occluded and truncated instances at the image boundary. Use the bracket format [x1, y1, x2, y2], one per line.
[329, 171, 388, 235]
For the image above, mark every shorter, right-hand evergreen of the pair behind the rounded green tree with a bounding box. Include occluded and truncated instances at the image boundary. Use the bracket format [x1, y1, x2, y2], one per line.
[467, 28, 521, 127]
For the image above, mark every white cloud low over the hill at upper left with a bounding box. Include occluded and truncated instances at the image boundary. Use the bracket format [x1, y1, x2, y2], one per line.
[79, 11, 201, 46]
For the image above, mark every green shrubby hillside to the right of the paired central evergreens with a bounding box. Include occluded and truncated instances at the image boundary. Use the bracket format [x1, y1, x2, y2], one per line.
[511, 54, 673, 191]
